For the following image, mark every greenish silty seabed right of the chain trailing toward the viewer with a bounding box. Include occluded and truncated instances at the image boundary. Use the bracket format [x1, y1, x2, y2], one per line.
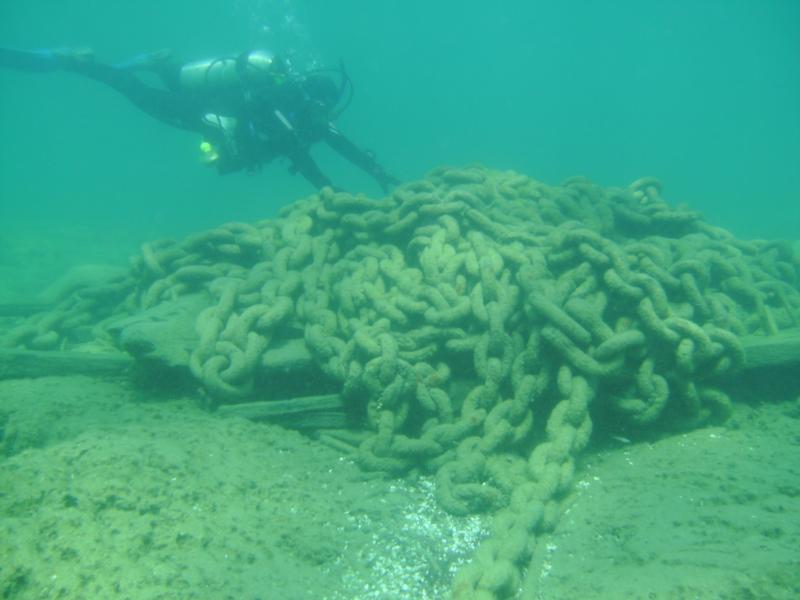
[531, 399, 800, 600]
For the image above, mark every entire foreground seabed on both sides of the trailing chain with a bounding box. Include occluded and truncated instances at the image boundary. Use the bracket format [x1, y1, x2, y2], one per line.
[0, 377, 800, 600]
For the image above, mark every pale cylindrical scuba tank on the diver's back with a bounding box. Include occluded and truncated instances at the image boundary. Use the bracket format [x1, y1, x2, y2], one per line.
[179, 50, 286, 90]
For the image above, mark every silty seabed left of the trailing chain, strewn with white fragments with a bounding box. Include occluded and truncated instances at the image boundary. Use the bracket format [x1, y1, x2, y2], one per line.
[0, 377, 484, 600]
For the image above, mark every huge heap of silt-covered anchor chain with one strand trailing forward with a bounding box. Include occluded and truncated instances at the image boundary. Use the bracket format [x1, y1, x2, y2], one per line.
[3, 167, 800, 599]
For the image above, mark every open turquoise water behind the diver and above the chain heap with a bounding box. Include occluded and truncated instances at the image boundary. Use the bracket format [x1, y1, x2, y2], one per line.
[0, 0, 800, 251]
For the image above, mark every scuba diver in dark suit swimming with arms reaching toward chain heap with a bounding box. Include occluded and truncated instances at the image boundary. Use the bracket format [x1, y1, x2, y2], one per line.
[0, 48, 399, 193]
